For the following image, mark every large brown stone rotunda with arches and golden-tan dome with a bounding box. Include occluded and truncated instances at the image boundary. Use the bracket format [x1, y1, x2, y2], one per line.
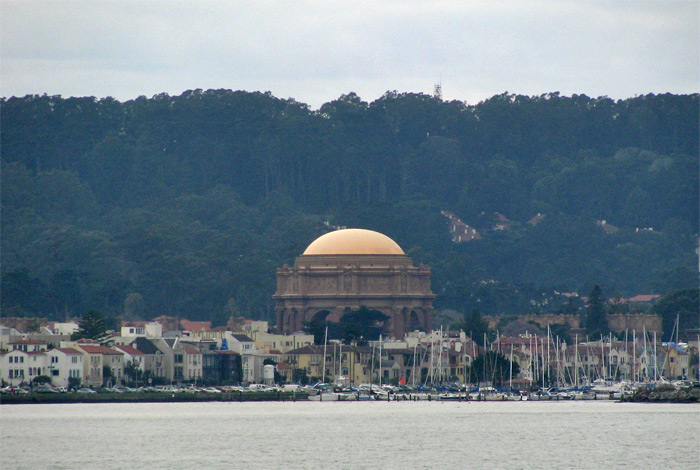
[273, 229, 435, 338]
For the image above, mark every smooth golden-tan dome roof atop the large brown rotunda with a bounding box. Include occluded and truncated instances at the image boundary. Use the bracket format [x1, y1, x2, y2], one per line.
[304, 228, 405, 255]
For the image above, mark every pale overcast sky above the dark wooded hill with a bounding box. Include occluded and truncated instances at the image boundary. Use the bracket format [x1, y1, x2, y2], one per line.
[0, 0, 700, 109]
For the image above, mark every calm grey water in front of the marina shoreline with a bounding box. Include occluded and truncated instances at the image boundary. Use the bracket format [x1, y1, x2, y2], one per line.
[0, 401, 700, 470]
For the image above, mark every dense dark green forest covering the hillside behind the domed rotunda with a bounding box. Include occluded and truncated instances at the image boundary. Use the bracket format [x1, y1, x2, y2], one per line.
[0, 90, 699, 323]
